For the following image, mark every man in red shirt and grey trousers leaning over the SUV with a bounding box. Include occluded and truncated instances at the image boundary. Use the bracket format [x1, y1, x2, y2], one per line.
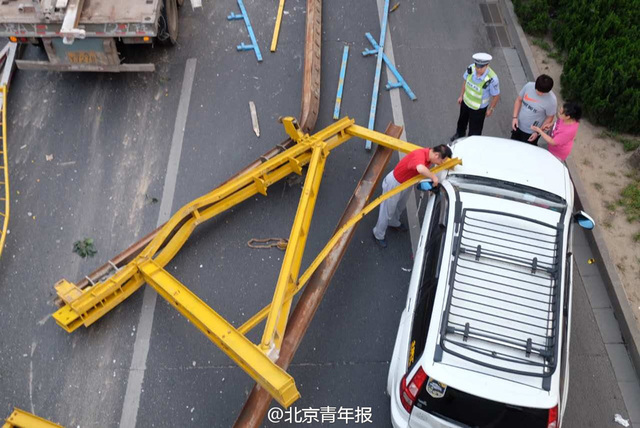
[373, 144, 453, 248]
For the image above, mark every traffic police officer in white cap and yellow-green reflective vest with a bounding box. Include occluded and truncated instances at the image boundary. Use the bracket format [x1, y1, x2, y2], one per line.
[451, 52, 500, 141]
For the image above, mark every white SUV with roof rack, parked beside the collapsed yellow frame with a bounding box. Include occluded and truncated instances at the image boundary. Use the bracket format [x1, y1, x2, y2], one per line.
[387, 136, 594, 428]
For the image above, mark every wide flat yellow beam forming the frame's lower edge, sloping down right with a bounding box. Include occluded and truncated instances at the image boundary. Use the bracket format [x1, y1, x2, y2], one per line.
[140, 261, 300, 407]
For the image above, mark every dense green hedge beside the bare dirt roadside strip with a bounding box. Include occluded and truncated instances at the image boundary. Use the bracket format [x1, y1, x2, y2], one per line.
[514, 0, 640, 133]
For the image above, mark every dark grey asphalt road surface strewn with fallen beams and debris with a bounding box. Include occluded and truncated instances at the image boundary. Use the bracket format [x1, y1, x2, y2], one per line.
[0, 0, 624, 427]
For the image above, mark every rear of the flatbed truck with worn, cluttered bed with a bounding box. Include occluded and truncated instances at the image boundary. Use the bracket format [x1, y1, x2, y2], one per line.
[0, 0, 201, 72]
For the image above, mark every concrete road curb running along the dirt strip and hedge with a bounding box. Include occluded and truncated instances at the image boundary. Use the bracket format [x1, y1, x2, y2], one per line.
[499, 0, 640, 378]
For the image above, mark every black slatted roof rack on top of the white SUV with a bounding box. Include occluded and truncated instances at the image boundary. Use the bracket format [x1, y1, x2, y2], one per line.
[435, 208, 563, 390]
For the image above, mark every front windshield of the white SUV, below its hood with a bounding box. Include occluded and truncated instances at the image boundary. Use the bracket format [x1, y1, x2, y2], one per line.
[447, 174, 567, 212]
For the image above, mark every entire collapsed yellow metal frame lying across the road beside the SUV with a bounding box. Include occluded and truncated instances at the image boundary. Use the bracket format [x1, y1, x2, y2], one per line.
[53, 117, 460, 407]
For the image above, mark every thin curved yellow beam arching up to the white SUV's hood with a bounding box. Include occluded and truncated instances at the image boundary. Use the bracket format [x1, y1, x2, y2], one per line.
[238, 157, 462, 334]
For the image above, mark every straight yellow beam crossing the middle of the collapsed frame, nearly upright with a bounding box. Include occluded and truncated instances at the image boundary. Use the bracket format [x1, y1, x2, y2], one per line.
[260, 141, 327, 360]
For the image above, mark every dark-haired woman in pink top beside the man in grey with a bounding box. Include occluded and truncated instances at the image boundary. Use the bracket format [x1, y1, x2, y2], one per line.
[531, 101, 582, 161]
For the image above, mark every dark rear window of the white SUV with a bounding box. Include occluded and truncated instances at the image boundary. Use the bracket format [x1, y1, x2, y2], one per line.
[415, 378, 549, 428]
